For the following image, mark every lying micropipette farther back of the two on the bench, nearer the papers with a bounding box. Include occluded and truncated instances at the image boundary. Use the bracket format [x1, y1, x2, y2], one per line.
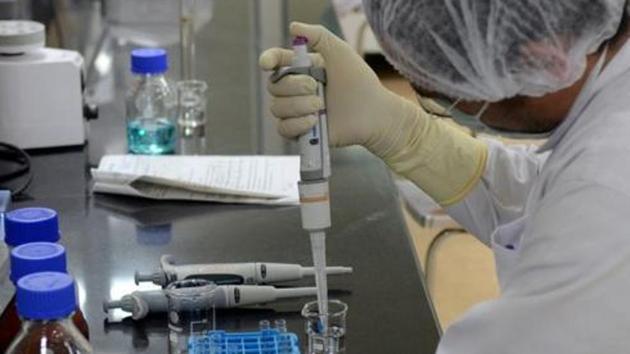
[135, 255, 352, 287]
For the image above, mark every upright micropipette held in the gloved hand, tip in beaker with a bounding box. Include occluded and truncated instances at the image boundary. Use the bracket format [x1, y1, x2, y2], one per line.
[270, 37, 331, 329]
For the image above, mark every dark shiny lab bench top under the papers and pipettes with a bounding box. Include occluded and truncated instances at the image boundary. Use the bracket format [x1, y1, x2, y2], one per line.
[2, 148, 439, 354]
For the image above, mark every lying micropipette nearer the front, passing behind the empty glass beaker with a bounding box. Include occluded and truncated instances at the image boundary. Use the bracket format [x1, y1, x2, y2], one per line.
[103, 285, 317, 320]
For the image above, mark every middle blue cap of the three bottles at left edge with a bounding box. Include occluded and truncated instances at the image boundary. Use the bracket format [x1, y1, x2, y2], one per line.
[10, 242, 67, 284]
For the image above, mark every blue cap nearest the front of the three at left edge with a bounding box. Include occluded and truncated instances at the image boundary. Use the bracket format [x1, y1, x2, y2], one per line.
[16, 272, 77, 320]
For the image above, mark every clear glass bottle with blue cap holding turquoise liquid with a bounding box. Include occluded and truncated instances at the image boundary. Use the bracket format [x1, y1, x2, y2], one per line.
[127, 48, 177, 155]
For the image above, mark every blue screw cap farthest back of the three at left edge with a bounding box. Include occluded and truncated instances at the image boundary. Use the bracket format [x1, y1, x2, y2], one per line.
[4, 208, 59, 247]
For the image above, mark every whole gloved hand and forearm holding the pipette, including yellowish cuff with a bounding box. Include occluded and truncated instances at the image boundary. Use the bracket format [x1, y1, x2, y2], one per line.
[260, 23, 487, 206]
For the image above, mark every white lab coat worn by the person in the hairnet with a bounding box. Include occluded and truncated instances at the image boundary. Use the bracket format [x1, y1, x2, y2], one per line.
[437, 39, 630, 354]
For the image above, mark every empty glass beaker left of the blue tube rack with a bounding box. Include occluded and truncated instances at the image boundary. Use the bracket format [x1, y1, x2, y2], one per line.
[165, 279, 216, 354]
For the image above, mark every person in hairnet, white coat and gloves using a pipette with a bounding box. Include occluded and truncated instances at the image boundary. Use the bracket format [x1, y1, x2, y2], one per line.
[260, 0, 630, 354]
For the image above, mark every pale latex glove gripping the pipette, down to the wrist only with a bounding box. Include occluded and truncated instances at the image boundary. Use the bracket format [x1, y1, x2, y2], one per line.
[260, 23, 417, 157]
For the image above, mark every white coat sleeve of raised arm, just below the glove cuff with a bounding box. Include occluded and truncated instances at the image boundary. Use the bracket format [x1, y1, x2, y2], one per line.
[447, 139, 548, 245]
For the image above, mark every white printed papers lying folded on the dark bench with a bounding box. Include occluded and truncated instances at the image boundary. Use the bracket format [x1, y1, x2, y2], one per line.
[92, 155, 300, 205]
